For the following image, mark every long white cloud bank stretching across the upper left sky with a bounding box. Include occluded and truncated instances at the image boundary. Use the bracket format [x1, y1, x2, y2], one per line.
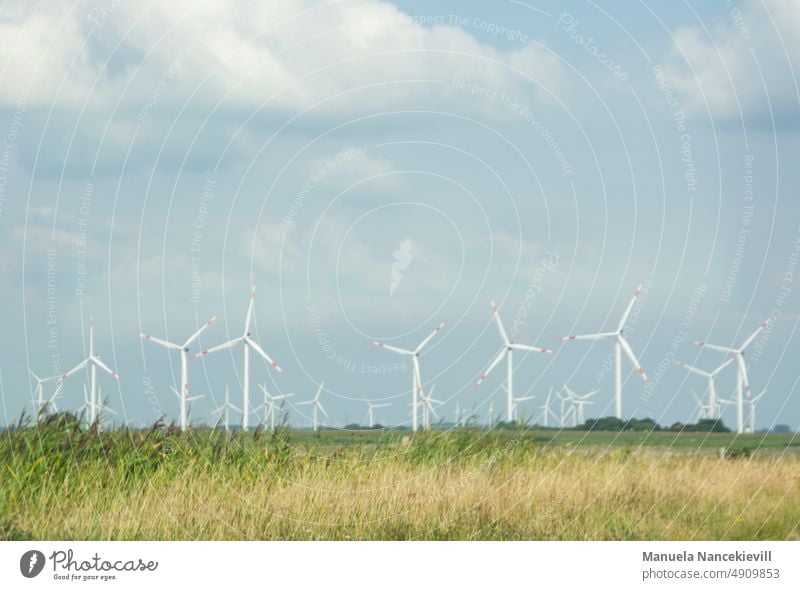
[0, 0, 560, 116]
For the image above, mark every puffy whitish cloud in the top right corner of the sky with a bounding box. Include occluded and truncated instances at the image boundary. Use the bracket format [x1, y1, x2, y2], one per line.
[664, 0, 800, 124]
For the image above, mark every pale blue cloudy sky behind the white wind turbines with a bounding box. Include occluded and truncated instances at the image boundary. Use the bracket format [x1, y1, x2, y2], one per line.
[0, 0, 800, 429]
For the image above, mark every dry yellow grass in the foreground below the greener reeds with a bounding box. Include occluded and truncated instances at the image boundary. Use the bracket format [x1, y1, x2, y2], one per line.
[3, 449, 800, 540]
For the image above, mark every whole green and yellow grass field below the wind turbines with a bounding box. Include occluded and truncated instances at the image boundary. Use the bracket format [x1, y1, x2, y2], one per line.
[0, 416, 800, 540]
